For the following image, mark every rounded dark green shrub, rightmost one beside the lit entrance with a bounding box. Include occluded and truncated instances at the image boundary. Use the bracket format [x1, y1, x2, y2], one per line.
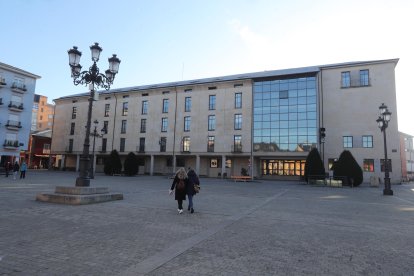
[333, 150, 364, 187]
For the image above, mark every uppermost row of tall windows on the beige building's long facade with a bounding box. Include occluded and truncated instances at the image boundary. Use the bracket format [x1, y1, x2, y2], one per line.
[72, 93, 242, 119]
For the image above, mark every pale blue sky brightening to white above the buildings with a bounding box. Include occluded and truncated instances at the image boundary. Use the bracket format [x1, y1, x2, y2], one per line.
[0, 0, 414, 135]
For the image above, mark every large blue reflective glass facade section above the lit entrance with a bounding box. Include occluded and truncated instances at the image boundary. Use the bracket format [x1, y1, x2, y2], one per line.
[253, 77, 317, 152]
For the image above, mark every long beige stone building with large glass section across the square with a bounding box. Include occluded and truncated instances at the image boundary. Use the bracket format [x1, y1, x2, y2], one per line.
[52, 59, 401, 183]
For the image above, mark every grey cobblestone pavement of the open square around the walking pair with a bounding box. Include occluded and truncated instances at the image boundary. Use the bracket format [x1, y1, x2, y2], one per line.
[0, 171, 414, 275]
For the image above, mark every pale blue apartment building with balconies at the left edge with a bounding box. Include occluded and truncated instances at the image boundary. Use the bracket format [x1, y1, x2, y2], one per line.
[0, 62, 40, 167]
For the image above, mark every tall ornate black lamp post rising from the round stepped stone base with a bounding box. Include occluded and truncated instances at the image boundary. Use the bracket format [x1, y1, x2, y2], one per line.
[68, 43, 121, 187]
